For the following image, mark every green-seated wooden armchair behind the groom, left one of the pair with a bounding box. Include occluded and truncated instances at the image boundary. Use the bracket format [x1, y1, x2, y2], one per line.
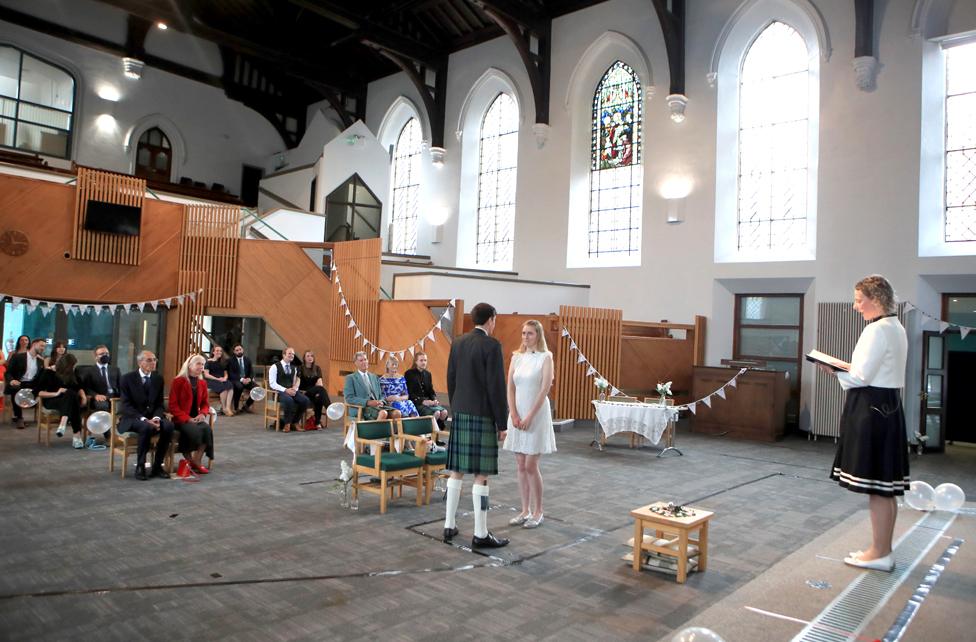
[352, 419, 427, 514]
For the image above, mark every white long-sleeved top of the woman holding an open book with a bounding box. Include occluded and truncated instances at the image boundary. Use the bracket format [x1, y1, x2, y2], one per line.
[837, 317, 908, 390]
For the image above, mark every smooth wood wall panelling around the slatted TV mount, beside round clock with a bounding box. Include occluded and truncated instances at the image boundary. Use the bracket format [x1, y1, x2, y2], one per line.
[0, 174, 183, 303]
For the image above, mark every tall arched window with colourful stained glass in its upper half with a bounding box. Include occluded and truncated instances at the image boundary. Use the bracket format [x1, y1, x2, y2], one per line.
[587, 60, 643, 260]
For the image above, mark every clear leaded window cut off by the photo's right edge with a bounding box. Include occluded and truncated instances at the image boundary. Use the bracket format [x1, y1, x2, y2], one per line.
[945, 42, 976, 242]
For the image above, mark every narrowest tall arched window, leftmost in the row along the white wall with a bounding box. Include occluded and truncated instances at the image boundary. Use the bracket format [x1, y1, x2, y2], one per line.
[390, 118, 423, 254]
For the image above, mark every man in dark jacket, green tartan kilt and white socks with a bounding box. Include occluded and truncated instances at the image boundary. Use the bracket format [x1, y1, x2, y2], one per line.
[444, 303, 508, 548]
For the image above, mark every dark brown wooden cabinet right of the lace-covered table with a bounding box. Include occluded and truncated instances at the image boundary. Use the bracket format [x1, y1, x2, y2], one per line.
[691, 366, 790, 441]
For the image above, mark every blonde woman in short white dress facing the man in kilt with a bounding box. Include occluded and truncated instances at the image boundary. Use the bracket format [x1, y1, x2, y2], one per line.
[502, 320, 556, 528]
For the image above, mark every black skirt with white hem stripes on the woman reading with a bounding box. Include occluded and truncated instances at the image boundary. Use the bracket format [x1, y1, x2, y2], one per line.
[830, 386, 910, 497]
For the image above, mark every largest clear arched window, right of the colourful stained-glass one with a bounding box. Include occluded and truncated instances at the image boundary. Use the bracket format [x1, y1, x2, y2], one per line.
[737, 22, 810, 252]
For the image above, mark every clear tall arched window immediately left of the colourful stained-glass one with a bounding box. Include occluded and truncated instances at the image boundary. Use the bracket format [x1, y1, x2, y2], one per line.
[476, 93, 519, 266]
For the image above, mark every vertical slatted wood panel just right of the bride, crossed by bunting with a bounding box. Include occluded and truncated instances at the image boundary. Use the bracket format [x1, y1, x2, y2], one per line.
[554, 305, 623, 419]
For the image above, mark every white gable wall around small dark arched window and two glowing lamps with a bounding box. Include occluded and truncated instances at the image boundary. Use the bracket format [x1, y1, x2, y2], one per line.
[0, 0, 284, 193]
